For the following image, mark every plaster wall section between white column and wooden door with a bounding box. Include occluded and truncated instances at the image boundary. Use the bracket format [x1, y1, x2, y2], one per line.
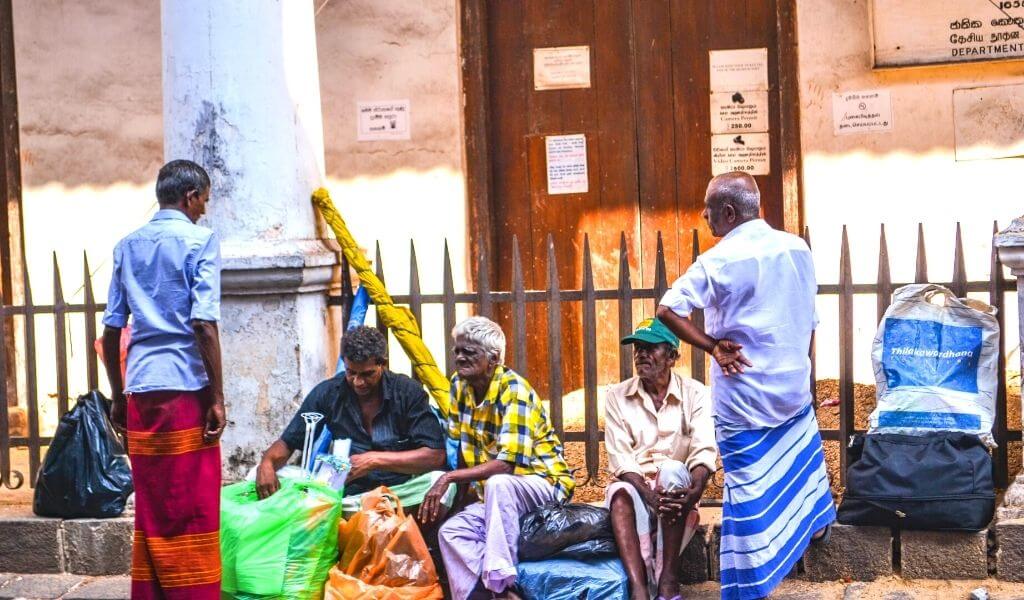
[316, 0, 467, 371]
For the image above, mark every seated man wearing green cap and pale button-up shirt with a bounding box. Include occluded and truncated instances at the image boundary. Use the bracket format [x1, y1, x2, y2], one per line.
[604, 318, 717, 599]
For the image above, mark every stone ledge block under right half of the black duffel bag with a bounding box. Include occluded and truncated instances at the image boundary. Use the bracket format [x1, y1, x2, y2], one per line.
[900, 529, 988, 580]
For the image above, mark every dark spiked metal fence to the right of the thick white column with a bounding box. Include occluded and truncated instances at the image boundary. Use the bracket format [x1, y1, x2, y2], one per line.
[329, 223, 1021, 487]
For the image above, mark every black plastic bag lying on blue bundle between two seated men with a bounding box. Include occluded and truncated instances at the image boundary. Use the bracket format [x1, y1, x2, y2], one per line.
[519, 502, 618, 560]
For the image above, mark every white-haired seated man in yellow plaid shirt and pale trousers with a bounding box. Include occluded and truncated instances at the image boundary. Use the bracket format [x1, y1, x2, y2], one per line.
[420, 316, 575, 600]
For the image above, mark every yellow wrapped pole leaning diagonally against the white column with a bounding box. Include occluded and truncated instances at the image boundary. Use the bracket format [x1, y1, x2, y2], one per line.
[313, 187, 449, 415]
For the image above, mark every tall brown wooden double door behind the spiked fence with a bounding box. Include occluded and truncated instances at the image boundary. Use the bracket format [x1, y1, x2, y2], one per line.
[463, 0, 800, 390]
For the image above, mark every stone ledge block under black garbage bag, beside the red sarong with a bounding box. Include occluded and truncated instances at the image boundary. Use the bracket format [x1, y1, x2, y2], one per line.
[63, 517, 134, 575]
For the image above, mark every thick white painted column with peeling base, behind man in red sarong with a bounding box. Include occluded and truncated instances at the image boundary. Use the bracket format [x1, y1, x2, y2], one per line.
[161, 0, 335, 478]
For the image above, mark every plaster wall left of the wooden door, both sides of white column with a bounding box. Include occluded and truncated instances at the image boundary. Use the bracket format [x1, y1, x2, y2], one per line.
[13, 0, 466, 431]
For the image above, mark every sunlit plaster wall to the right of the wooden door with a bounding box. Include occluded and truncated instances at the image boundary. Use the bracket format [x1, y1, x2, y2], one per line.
[798, 0, 1024, 382]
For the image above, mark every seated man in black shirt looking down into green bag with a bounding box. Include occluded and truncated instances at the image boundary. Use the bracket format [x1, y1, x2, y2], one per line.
[256, 327, 455, 518]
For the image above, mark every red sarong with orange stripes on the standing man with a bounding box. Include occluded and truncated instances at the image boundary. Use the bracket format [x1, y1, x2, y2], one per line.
[128, 390, 220, 600]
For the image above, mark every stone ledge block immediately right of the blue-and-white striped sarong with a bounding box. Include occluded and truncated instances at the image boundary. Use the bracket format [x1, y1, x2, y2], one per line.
[803, 523, 893, 582]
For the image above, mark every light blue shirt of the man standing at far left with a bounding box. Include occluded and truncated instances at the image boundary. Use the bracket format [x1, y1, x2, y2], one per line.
[103, 209, 220, 393]
